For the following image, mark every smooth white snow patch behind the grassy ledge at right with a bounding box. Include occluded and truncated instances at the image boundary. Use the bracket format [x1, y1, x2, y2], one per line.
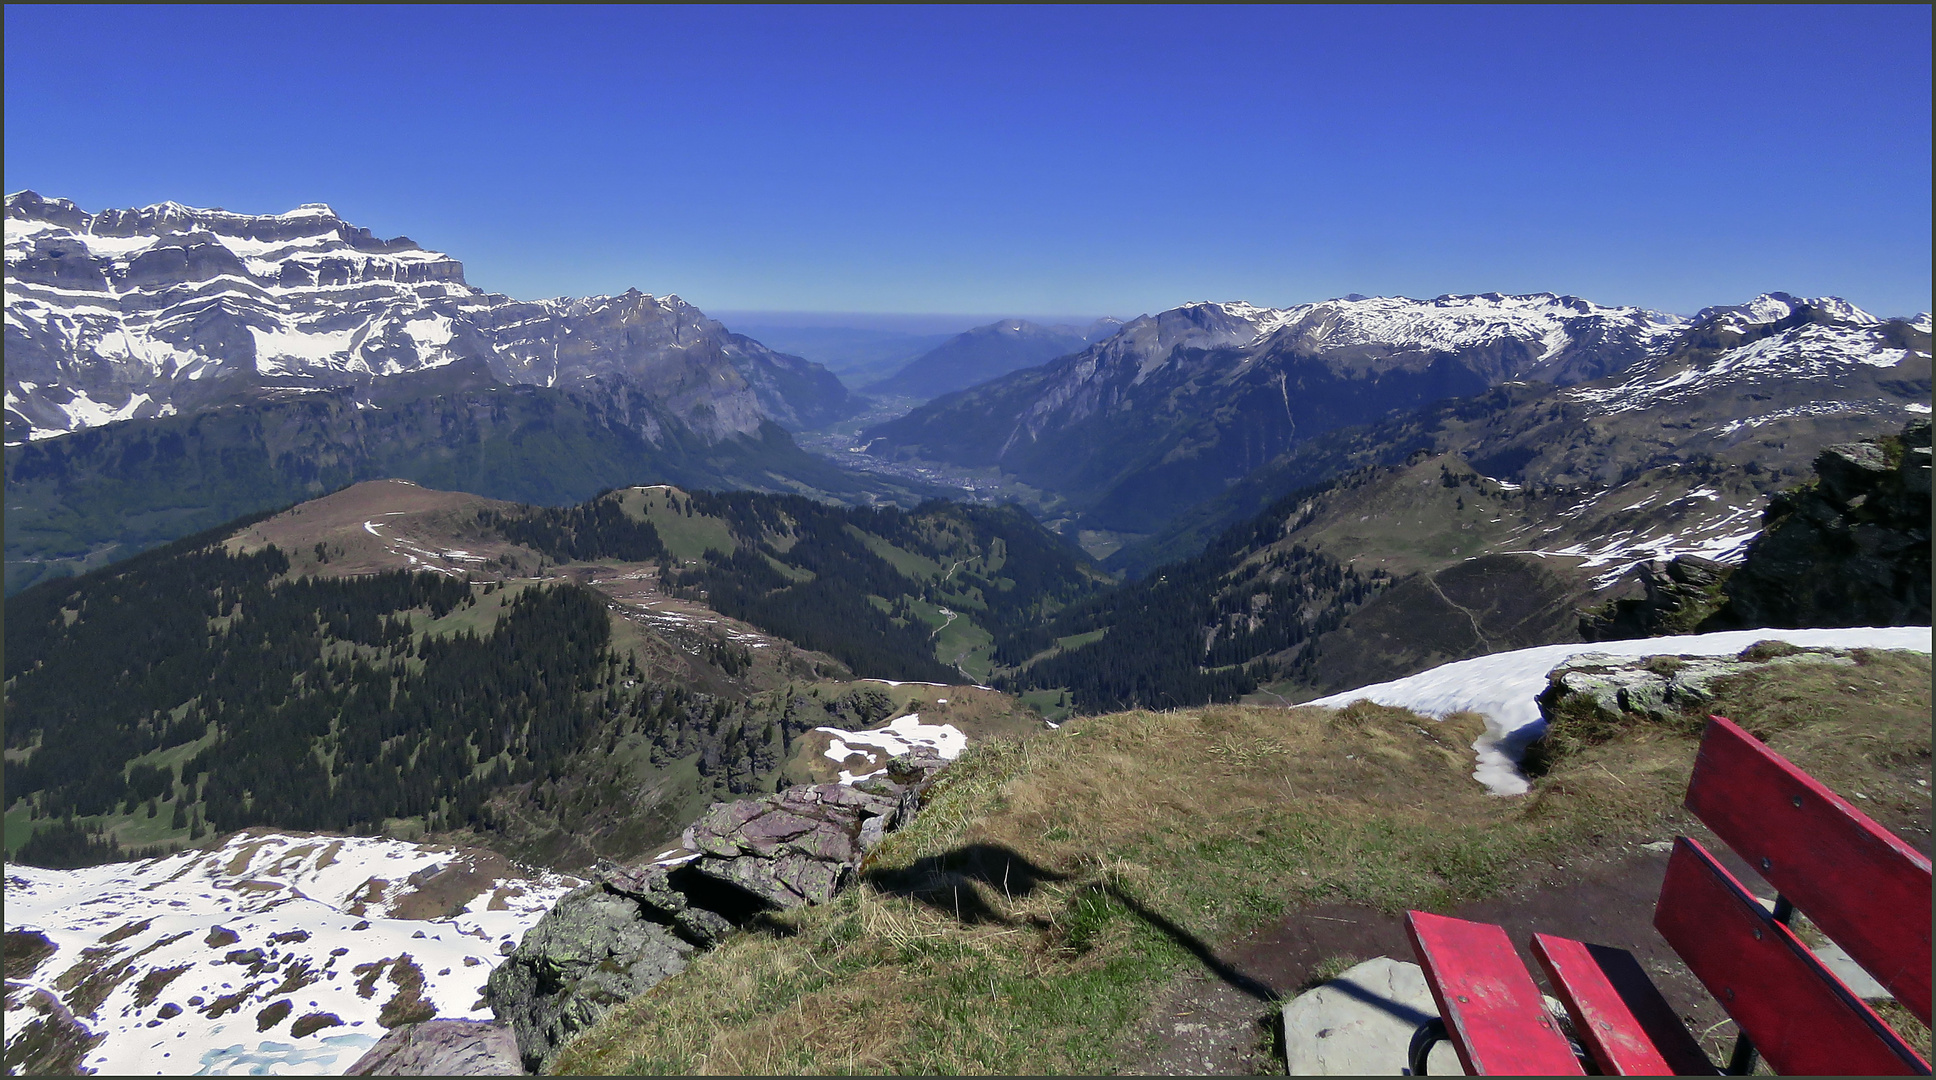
[1307, 627, 1930, 795]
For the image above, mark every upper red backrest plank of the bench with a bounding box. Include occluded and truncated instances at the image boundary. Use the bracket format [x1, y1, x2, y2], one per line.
[1686, 716, 1930, 1024]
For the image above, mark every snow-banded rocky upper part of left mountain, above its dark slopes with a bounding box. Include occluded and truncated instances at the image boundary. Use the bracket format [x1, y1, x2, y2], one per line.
[6, 192, 846, 443]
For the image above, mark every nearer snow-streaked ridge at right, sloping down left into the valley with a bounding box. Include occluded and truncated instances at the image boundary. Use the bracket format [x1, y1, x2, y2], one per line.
[1115, 292, 1930, 584]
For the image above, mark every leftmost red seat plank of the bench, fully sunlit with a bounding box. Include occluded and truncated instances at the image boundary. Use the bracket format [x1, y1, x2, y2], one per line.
[1406, 912, 1582, 1076]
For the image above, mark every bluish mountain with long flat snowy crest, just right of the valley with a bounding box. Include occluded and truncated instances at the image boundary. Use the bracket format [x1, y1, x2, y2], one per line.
[863, 292, 1684, 530]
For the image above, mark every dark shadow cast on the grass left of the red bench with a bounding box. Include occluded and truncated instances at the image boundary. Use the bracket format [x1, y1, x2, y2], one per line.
[863, 844, 1278, 1003]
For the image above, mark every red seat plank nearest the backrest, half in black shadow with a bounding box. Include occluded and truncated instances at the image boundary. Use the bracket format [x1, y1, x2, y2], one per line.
[1533, 933, 1717, 1076]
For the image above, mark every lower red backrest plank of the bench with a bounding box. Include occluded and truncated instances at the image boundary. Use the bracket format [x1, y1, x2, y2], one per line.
[1653, 836, 1930, 1076]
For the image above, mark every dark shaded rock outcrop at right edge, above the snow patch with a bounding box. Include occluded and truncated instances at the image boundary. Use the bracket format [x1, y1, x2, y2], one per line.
[1700, 420, 1930, 631]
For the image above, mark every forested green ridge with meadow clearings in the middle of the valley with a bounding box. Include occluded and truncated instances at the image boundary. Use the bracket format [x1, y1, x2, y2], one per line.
[491, 488, 1107, 683]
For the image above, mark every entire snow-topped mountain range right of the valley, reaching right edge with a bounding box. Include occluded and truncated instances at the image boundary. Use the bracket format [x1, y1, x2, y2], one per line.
[860, 294, 1930, 554]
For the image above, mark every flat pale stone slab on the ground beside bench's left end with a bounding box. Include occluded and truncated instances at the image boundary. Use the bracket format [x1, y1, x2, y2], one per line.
[1284, 956, 1466, 1076]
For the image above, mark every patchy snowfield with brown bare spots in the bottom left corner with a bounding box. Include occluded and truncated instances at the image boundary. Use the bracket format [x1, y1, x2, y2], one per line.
[6, 830, 579, 1076]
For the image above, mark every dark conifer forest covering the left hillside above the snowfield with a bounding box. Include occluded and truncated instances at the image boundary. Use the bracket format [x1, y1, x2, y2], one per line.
[6, 548, 618, 847]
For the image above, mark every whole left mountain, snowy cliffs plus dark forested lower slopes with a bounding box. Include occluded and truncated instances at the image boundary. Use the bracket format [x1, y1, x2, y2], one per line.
[6, 192, 943, 592]
